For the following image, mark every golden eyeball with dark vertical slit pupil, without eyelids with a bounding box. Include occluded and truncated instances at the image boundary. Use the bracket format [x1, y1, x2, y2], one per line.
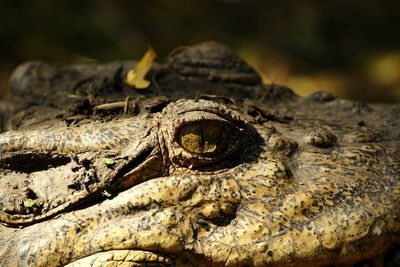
[179, 122, 223, 154]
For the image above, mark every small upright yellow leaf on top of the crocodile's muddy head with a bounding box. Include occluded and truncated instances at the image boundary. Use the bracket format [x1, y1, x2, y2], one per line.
[126, 47, 156, 89]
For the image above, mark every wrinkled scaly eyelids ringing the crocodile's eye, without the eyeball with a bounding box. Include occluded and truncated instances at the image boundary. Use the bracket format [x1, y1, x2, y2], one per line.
[159, 100, 247, 170]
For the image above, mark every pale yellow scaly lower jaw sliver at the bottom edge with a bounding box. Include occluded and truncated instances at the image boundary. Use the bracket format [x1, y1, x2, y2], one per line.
[65, 249, 176, 267]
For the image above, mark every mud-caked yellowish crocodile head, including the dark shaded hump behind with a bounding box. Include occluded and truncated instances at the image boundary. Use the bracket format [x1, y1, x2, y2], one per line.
[0, 42, 400, 267]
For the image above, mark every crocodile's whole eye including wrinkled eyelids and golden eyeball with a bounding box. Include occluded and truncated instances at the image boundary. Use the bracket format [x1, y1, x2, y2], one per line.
[160, 100, 252, 171]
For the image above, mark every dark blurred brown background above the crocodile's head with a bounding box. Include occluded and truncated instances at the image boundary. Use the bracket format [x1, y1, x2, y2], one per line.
[0, 0, 400, 102]
